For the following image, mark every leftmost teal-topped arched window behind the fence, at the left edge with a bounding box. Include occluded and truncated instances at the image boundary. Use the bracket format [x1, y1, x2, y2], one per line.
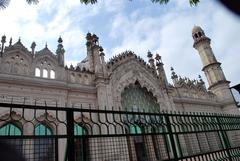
[0, 123, 23, 153]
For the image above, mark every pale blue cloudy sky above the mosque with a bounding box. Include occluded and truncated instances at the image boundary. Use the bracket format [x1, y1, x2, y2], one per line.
[0, 0, 240, 86]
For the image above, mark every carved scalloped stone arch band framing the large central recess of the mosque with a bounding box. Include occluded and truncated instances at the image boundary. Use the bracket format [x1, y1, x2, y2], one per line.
[111, 61, 164, 107]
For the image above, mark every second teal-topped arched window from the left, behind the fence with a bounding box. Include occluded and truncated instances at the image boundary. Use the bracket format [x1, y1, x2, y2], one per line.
[34, 124, 54, 161]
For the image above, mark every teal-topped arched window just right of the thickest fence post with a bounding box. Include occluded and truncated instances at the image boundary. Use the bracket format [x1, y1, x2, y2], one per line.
[74, 124, 89, 161]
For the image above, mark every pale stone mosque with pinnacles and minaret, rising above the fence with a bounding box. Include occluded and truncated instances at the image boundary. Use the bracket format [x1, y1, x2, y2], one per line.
[0, 26, 238, 161]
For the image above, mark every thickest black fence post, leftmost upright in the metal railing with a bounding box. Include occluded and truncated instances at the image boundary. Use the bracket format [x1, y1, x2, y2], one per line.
[67, 109, 75, 161]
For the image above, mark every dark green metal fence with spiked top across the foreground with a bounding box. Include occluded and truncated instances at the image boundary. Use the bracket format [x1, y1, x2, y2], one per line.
[0, 103, 240, 161]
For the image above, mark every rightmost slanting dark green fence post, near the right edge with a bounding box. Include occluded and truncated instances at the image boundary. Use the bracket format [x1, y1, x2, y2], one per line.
[216, 115, 232, 161]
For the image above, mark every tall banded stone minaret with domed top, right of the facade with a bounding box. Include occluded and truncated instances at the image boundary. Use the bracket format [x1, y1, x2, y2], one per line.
[192, 26, 236, 111]
